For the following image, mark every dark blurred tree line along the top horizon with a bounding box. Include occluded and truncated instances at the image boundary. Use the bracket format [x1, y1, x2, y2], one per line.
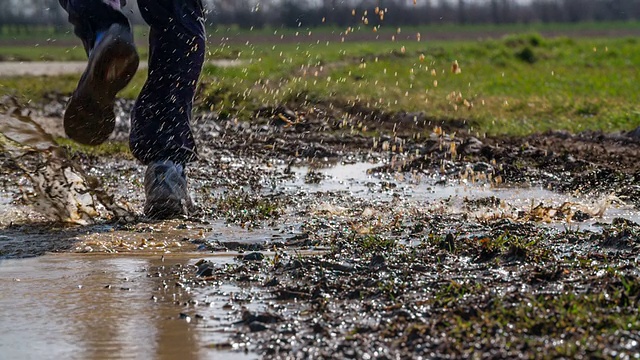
[0, 0, 640, 33]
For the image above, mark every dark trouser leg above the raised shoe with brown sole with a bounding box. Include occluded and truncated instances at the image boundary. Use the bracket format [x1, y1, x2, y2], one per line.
[58, 0, 130, 54]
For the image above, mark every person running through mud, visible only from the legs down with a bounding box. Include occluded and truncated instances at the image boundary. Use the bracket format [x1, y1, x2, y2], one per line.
[59, 0, 205, 219]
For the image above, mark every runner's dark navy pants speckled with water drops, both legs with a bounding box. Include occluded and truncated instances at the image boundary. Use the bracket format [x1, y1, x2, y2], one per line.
[59, 0, 205, 164]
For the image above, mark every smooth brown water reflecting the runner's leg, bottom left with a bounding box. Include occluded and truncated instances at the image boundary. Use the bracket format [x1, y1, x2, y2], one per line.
[0, 255, 255, 359]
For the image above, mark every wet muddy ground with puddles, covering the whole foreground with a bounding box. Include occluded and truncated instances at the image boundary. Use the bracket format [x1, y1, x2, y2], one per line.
[0, 98, 640, 359]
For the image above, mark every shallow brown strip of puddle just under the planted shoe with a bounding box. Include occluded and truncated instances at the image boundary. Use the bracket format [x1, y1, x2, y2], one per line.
[0, 218, 295, 259]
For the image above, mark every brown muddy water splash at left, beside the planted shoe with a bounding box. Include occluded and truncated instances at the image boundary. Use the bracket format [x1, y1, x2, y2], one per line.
[0, 101, 135, 225]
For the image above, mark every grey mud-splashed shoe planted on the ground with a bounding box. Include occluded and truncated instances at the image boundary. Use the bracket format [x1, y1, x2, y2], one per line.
[144, 160, 194, 220]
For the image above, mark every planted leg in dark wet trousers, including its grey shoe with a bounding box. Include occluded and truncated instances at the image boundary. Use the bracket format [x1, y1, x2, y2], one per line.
[134, 0, 206, 218]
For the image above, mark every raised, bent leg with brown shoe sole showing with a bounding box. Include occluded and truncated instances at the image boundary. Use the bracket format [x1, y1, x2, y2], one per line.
[59, 0, 139, 145]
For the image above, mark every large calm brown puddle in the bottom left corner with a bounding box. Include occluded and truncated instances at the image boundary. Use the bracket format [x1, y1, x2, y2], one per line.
[0, 254, 266, 359]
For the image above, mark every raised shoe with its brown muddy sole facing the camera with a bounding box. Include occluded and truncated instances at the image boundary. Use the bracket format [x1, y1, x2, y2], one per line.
[64, 24, 140, 145]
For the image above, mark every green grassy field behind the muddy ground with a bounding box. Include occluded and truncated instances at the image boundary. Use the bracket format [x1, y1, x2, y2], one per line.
[0, 26, 640, 135]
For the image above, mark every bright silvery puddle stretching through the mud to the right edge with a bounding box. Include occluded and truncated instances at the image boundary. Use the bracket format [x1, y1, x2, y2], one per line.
[281, 162, 640, 232]
